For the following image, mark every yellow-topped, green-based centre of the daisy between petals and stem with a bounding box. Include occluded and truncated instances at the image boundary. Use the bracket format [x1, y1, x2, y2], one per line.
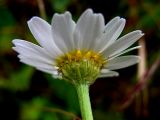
[56, 50, 106, 84]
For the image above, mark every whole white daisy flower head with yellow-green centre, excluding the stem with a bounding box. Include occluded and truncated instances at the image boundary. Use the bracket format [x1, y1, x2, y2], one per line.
[13, 9, 143, 83]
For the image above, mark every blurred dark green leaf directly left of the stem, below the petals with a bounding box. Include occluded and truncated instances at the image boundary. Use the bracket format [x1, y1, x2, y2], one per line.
[46, 76, 79, 114]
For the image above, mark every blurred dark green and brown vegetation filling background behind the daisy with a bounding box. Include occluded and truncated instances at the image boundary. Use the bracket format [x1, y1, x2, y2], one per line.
[0, 0, 160, 120]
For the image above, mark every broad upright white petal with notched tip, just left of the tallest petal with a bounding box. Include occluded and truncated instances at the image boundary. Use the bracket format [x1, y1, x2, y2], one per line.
[52, 12, 75, 52]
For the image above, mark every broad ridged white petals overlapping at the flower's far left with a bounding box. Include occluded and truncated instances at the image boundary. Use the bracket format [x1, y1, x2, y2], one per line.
[13, 39, 57, 74]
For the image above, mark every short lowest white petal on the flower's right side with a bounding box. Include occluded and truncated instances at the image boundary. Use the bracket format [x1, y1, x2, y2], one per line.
[99, 69, 119, 78]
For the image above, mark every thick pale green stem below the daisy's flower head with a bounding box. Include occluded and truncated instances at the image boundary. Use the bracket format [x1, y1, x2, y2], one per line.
[76, 84, 93, 120]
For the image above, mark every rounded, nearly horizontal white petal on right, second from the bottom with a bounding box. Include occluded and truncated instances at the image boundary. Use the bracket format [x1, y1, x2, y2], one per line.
[104, 55, 140, 70]
